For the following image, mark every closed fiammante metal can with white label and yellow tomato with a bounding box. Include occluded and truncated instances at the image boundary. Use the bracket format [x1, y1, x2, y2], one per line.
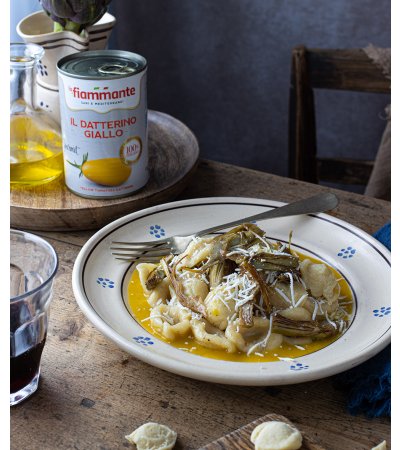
[57, 50, 149, 199]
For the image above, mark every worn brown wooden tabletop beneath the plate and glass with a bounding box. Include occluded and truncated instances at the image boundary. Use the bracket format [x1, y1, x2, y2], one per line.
[11, 160, 390, 450]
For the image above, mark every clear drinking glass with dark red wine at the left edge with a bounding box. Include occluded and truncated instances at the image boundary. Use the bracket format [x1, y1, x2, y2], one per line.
[10, 230, 58, 406]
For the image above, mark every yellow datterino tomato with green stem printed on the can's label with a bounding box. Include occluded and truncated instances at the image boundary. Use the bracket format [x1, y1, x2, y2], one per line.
[67, 153, 132, 186]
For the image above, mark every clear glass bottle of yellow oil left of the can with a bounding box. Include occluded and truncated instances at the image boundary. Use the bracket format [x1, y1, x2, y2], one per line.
[10, 43, 64, 186]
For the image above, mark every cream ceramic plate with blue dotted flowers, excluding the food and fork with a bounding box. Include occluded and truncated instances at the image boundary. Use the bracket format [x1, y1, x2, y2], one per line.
[72, 197, 391, 386]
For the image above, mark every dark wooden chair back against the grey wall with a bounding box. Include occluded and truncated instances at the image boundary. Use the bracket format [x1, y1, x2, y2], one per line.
[289, 45, 390, 185]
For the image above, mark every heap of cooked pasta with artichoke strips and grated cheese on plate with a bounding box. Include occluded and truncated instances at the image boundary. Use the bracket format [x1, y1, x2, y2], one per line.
[137, 224, 346, 356]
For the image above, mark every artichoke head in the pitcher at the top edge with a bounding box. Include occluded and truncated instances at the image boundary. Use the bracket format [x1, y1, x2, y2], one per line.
[39, 0, 112, 34]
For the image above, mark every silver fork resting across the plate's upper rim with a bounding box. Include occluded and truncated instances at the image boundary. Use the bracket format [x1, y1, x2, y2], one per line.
[110, 193, 339, 262]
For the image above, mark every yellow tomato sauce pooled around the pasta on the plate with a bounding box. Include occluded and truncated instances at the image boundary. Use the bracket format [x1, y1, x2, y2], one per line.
[128, 252, 354, 363]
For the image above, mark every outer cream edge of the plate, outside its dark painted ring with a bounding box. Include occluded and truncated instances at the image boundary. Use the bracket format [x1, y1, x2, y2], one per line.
[72, 197, 391, 386]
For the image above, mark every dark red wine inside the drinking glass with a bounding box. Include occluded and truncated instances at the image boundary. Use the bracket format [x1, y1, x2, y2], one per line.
[10, 338, 46, 394]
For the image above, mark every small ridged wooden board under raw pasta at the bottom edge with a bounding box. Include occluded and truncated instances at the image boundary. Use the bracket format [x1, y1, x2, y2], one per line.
[199, 414, 325, 450]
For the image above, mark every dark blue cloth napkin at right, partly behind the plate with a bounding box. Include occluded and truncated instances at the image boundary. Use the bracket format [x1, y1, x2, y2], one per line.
[336, 222, 392, 418]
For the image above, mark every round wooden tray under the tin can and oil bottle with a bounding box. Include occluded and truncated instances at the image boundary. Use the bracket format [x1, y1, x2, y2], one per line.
[10, 110, 200, 231]
